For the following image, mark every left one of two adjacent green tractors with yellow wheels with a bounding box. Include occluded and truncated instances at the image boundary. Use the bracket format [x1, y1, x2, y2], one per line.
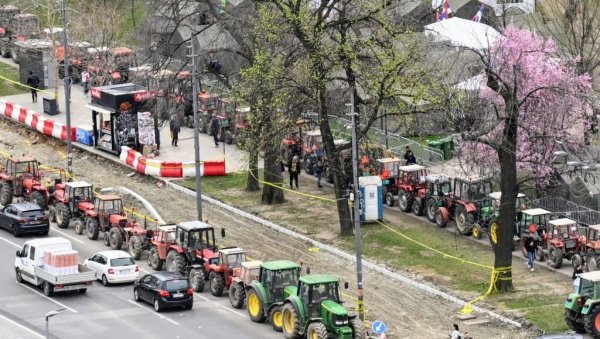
[246, 260, 301, 332]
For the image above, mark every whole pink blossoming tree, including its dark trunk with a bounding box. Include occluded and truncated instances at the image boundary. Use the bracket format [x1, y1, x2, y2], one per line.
[458, 27, 591, 292]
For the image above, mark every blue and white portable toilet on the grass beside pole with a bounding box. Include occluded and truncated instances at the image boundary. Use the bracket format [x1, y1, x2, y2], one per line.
[358, 176, 383, 222]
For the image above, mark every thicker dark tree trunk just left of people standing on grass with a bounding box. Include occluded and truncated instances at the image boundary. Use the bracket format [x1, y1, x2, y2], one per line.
[262, 138, 285, 204]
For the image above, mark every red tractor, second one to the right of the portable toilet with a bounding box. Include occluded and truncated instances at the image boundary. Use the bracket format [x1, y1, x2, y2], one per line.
[394, 165, 427, 212]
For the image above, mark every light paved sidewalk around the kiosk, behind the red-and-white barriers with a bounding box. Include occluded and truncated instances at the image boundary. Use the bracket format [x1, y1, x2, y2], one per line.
[4, 81, 253, 172]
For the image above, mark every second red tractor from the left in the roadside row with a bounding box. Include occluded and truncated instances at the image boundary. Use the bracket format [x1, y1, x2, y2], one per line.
[48, 181, 96, 234]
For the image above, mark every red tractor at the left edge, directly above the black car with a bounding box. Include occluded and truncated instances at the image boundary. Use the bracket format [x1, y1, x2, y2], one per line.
[0, 157, 48, 209]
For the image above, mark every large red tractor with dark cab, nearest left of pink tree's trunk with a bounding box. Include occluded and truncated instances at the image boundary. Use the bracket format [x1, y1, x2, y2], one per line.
[436, 178, 492, 235]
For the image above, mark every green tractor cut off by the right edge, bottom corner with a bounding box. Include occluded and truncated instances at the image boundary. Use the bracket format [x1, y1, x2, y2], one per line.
[565, 271, 600, 338]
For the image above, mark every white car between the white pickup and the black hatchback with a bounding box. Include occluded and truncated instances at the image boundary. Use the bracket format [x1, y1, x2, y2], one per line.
[83, 251, 140, 286]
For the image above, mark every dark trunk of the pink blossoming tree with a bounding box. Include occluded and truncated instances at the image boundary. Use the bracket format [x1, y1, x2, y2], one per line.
[491, 95, 519, 293]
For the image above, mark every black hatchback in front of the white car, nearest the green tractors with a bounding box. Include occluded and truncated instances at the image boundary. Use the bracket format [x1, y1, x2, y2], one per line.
[133, 272, 194, 312]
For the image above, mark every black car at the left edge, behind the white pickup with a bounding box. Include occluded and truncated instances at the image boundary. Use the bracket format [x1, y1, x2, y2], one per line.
[0, 202, 50, 237]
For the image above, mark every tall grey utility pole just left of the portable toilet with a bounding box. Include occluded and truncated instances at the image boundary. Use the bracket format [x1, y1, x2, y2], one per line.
[350, 88, 365, 321]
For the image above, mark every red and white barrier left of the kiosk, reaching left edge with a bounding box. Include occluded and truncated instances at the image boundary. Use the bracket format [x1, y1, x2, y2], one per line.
[0, 99, 76, 141]
